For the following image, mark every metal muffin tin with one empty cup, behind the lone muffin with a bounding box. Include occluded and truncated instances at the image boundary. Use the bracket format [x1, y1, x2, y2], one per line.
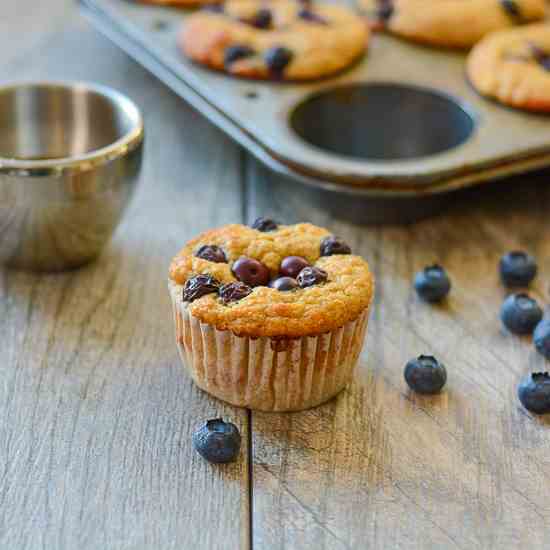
[80, 0, 550, 221]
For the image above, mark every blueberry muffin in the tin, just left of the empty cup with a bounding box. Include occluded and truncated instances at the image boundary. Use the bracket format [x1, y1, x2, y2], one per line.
[179, 0, 369, 80]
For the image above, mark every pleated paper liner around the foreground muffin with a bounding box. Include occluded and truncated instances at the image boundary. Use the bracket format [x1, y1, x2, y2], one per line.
[170, 283, 369, 411]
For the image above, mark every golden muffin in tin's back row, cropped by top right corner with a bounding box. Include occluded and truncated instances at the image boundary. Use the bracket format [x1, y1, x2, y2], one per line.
[361, 0, 545, 48]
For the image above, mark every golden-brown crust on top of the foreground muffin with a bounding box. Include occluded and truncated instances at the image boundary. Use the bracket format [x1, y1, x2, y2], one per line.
[170, 223, 374, 338]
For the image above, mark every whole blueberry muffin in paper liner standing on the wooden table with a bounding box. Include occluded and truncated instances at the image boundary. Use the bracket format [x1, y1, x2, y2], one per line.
[169, 219, 374, 411]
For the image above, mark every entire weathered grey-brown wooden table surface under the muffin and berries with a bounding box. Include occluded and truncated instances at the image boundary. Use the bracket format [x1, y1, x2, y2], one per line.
[0, 0, 550, 550]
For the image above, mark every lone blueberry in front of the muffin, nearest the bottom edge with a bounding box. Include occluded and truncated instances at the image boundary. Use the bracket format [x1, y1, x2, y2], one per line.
[193, 418, 241, 463]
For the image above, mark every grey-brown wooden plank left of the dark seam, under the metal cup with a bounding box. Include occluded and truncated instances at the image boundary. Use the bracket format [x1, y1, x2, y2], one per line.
[0, 5, 249, 550]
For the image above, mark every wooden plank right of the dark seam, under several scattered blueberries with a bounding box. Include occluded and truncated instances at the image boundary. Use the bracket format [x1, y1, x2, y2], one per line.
[248, 163, 550, 550]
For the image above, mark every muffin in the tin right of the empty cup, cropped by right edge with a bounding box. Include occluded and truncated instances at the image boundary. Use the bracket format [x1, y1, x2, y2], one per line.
[467, 23, 550, 112]
